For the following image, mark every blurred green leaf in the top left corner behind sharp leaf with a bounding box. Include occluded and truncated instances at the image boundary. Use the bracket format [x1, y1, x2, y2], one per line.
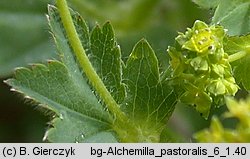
[0, 0, 55, 77]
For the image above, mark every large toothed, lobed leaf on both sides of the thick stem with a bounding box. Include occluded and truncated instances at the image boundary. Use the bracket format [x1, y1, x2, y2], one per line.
[6, 6, 177, 142]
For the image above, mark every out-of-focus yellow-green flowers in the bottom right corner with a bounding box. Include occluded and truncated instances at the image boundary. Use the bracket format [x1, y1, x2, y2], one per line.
[194, 98, 250, 142]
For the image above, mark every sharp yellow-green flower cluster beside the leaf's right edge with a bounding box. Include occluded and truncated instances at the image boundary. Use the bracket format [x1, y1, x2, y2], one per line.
[168, 21, 238, 118]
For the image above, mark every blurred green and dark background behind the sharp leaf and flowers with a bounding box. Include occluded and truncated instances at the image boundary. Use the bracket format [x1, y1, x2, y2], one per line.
[0, 0, 217, 142]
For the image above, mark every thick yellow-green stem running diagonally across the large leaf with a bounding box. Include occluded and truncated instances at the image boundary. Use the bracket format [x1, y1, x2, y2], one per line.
[57, 0, 128, 123]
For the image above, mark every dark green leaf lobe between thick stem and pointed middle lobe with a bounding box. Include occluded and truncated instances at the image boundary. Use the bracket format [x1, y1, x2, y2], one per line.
[89, 22, 125, 103]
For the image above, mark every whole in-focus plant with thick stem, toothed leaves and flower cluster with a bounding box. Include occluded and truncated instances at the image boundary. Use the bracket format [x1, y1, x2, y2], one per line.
[2, 0, 250, 142]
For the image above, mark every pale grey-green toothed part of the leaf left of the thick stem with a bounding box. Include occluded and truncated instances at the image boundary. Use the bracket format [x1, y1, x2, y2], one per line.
[5, 6, 121, 142]
